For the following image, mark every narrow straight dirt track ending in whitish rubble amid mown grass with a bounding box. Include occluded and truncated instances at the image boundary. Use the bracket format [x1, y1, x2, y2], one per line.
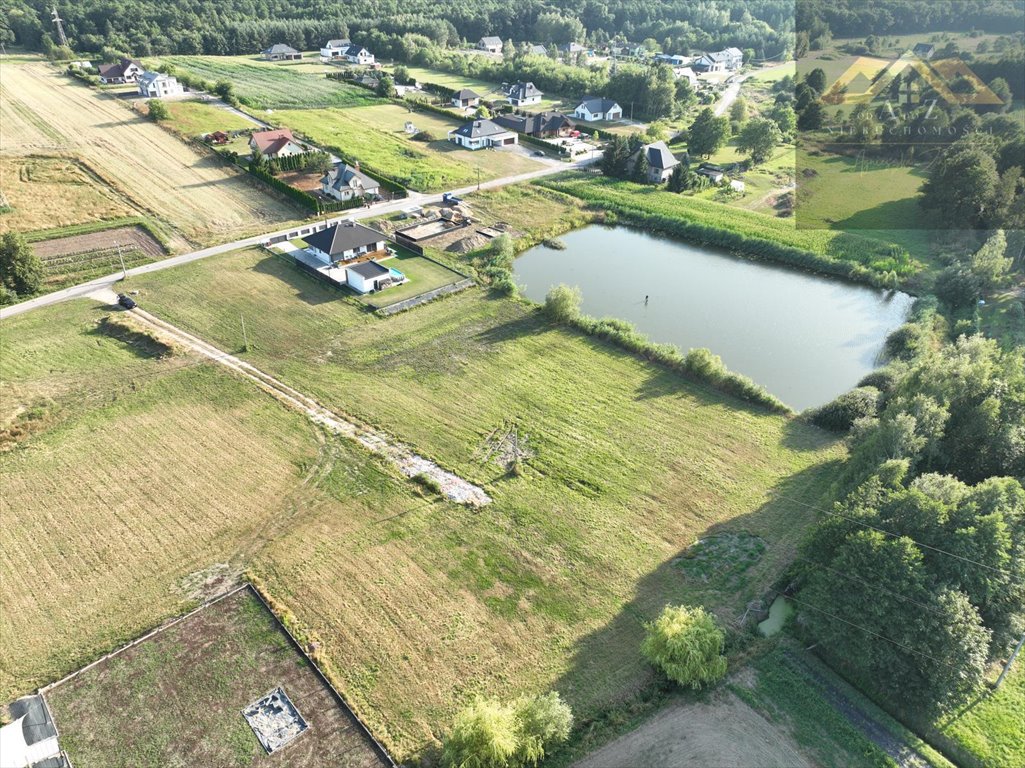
[126, 296, 491, 507]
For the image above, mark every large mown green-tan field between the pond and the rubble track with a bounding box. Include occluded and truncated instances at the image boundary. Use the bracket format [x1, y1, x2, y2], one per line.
[130, 244, 838, 759]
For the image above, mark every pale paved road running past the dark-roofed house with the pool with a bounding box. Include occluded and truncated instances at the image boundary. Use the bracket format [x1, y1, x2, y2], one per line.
[0, 152, 601, 320]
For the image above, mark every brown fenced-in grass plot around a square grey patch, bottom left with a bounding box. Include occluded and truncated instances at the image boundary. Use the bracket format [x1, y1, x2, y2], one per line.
[46, 591, 385, 768]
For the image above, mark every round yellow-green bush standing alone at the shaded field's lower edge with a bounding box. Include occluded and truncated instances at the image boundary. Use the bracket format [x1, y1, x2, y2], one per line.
[641, 605, 726, 688]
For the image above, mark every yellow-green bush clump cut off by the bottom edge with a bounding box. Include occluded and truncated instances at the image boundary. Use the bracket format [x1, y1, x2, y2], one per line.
[442, 691, 573, 768]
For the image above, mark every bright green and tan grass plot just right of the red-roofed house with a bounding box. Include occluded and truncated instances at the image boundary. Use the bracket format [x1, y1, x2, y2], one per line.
[273, 104, 542, 192]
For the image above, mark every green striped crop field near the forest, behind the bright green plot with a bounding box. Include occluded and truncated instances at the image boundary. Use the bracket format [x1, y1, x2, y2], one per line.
[151, 56, 376, 110]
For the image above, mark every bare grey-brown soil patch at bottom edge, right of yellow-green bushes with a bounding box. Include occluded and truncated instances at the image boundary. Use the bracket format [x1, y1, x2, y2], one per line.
[575, 692, 814, 768]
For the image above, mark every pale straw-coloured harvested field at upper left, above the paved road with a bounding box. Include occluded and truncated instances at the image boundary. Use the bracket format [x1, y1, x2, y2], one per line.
[0, 62, 297, 245]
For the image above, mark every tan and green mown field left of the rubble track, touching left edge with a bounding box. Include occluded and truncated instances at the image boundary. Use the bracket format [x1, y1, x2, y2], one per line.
[0, 299, 320, 700]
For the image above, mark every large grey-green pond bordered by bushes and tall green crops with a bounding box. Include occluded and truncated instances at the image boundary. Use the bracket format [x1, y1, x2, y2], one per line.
[514, 225, 913, 410]
